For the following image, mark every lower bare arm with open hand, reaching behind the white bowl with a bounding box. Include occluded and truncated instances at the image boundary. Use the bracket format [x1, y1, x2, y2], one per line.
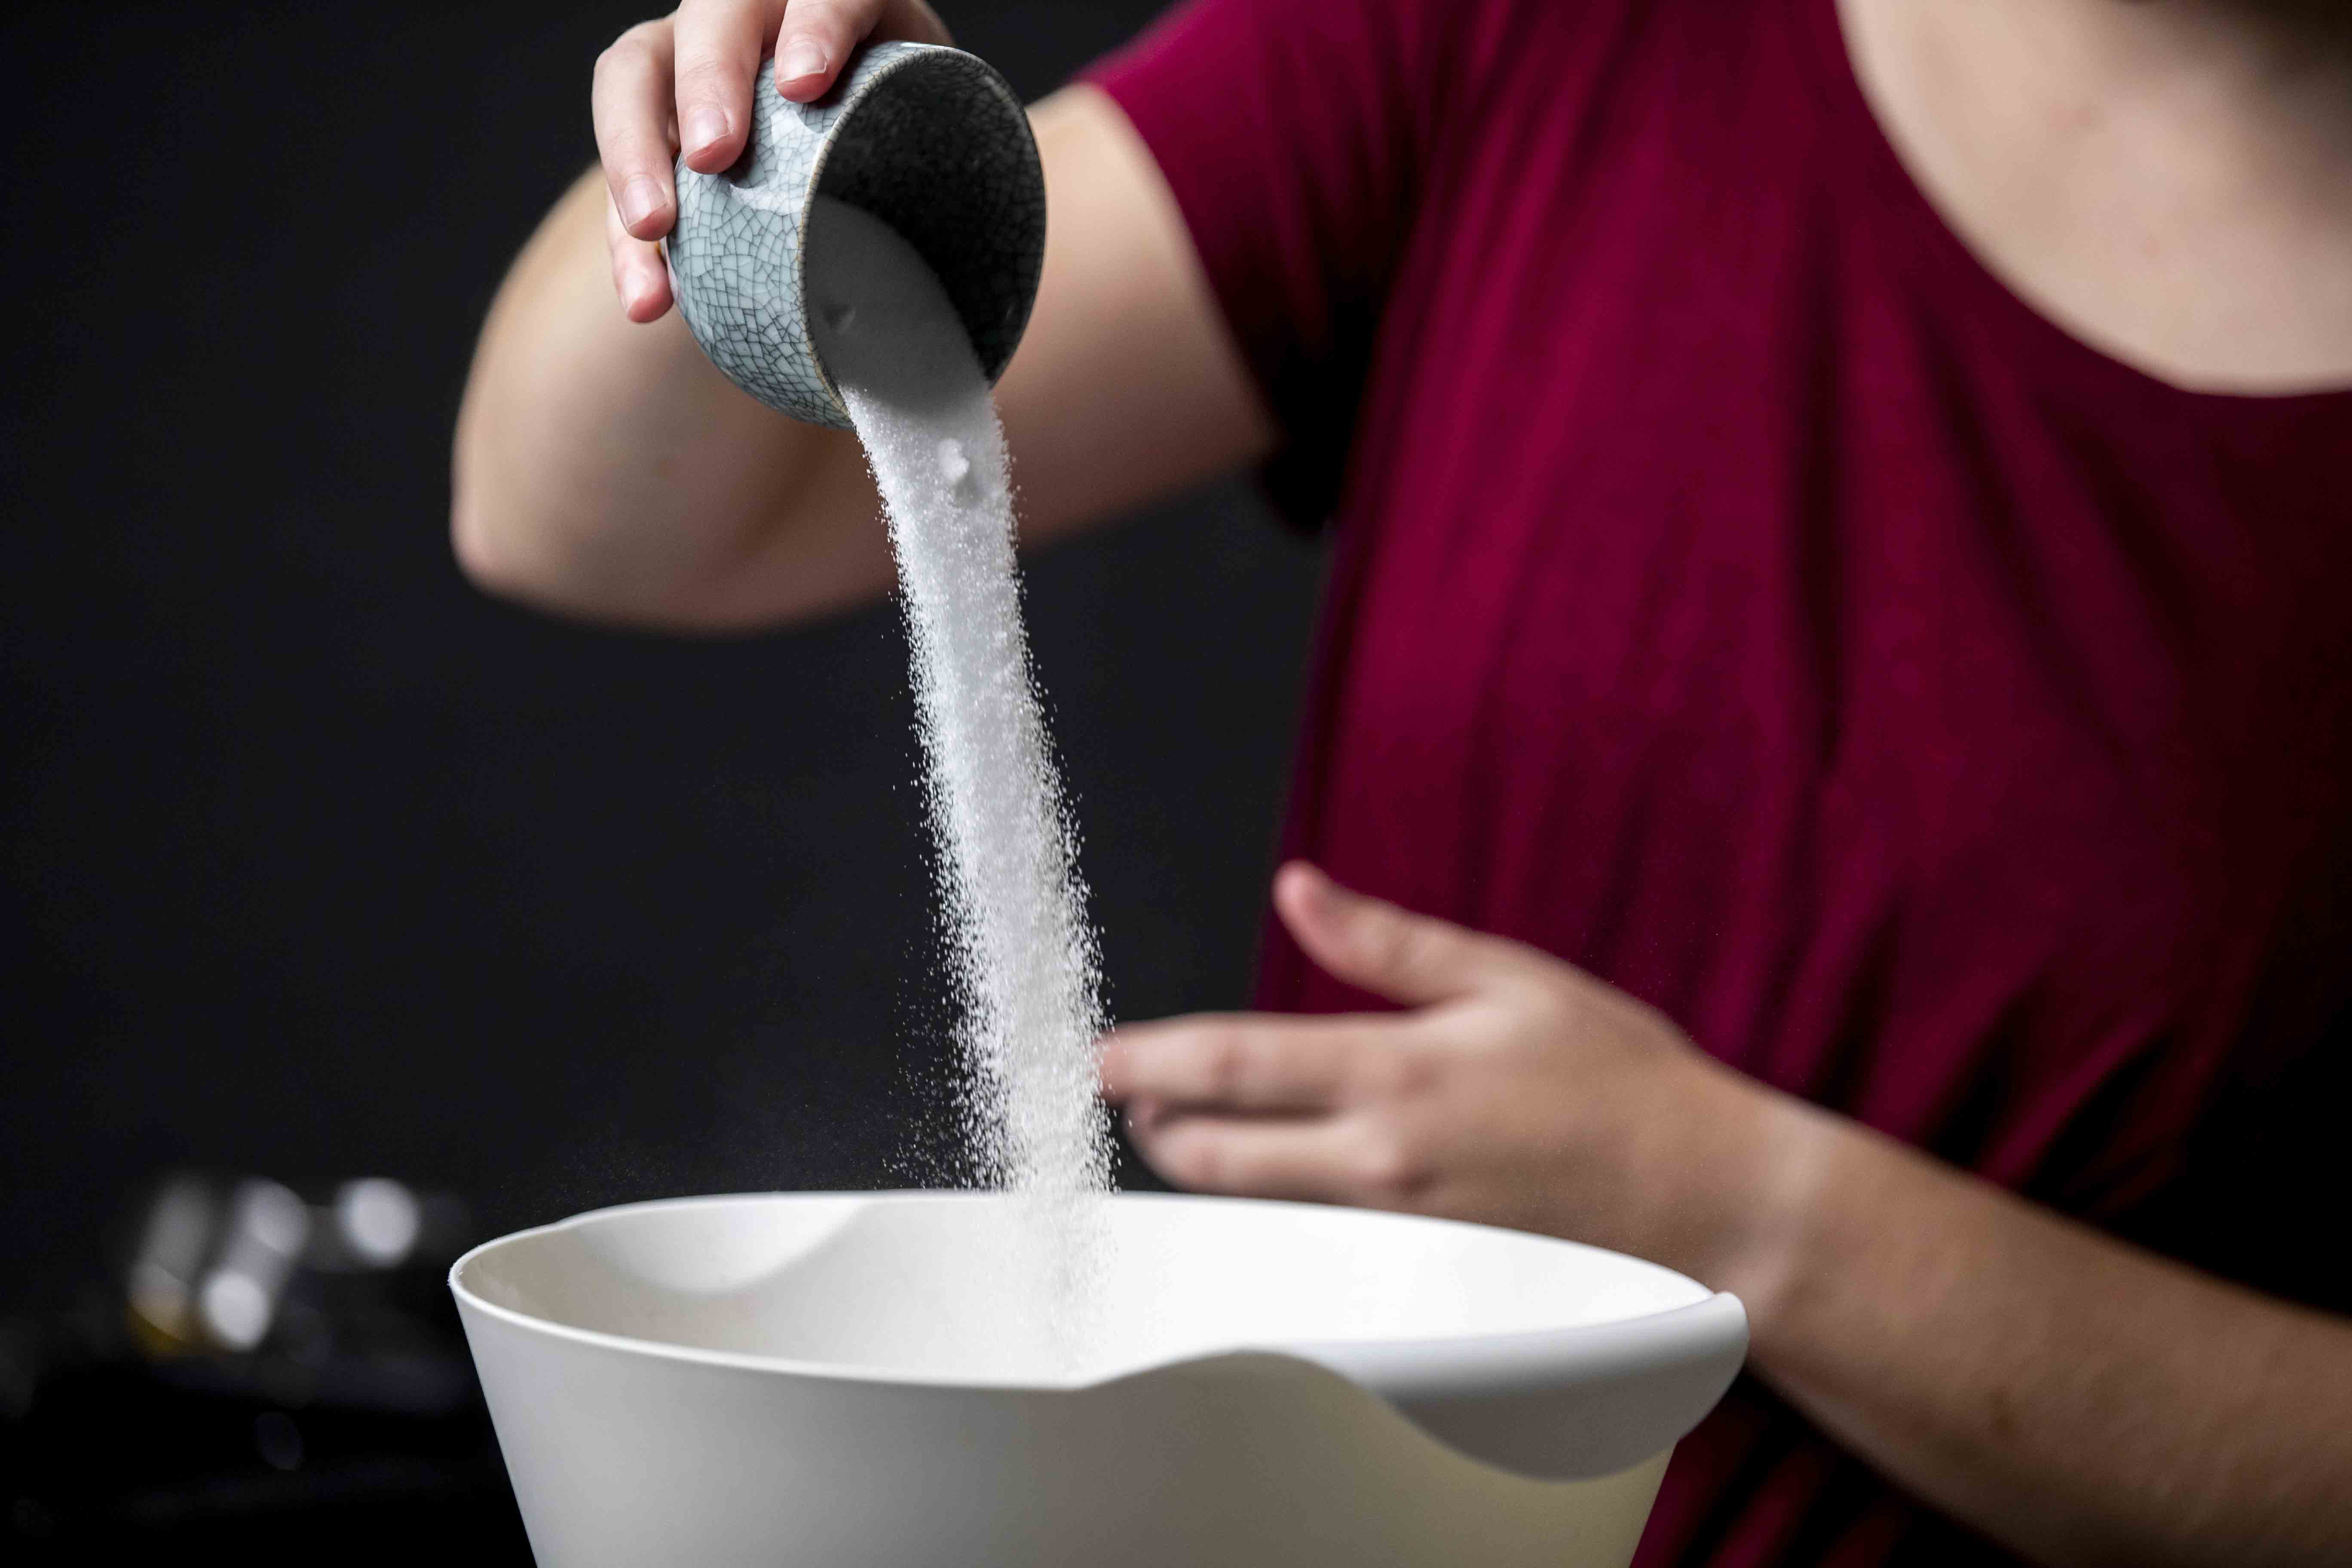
[1103, 865, 2352, 1568]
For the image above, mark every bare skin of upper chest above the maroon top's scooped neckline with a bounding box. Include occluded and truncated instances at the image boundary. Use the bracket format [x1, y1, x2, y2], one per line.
[1839, 0, 2352, 392]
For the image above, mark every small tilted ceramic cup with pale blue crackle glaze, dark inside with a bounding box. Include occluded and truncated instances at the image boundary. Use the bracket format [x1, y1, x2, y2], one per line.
[663, 42, 1044, 430]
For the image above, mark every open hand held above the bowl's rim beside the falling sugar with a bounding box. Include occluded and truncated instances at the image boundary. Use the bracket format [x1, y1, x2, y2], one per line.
[1103, 865, 1820, 1295]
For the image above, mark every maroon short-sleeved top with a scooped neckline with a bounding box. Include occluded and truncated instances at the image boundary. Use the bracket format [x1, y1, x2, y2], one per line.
[1093, 0, 2352, 1563]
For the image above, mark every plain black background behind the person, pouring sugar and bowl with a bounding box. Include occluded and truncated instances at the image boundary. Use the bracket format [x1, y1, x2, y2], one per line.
[0, 0, 1317, 1542]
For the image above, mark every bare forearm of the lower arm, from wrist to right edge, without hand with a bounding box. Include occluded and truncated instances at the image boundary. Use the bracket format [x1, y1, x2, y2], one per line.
[1755, 1112, 2352, 1566]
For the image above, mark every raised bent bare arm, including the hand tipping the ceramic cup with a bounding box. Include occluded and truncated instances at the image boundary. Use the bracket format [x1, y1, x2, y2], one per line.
[452, 0, 1272, 630]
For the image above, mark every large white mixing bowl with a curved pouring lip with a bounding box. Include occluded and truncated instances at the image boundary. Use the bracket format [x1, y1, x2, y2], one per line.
[449, 1192, 1748, 1568]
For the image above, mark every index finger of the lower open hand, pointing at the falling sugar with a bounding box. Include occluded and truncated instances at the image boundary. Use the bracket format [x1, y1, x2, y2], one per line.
[1103, 1013, 1402, 1114]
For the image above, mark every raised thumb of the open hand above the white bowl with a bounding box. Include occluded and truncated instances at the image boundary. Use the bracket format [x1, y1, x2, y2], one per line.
[1275, 861, 1510, 1006]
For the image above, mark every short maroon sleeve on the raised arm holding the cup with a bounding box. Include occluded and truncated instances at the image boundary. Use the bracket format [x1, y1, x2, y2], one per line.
[1087, 0, 1444, 527]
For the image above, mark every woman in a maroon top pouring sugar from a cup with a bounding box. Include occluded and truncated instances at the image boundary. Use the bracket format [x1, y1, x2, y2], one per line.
[454, 0, 2352, 1563]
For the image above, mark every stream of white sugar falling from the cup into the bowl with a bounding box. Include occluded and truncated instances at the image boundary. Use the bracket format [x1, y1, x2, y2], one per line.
[804, 197, 1110, 1359]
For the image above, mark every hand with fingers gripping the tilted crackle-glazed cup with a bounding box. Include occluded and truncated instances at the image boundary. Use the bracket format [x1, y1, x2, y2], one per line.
[593, 0, 948, 322]
